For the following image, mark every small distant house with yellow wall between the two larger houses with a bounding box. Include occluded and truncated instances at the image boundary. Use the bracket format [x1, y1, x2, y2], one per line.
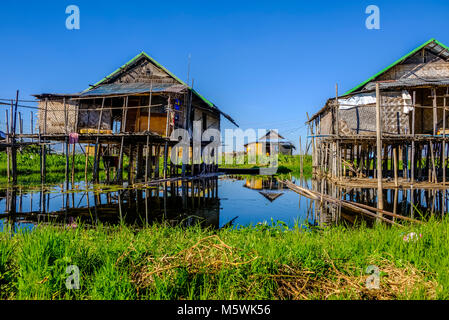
[245, 130, 296, 156]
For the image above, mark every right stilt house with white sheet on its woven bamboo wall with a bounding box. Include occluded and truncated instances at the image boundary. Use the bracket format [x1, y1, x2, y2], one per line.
[307, 39, 449, 187]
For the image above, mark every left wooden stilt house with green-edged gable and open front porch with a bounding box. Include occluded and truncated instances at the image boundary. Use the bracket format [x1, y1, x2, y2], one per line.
[31, 52, 236, 182]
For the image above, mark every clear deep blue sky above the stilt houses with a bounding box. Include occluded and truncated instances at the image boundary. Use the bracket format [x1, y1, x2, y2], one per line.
[0, 0, 449, 153]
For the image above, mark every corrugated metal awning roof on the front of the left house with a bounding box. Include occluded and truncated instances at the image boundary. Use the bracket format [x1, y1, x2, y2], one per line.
[81, 83, 187, 97]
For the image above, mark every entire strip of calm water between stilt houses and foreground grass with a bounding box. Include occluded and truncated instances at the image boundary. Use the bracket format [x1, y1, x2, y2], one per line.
[0, 175, 448, 230]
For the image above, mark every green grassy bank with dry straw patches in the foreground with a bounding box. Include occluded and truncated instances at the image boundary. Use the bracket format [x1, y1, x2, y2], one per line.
[0, 218, 449, 299]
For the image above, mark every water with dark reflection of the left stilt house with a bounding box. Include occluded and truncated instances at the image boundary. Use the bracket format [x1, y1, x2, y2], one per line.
[0, 178, 220, 228]
